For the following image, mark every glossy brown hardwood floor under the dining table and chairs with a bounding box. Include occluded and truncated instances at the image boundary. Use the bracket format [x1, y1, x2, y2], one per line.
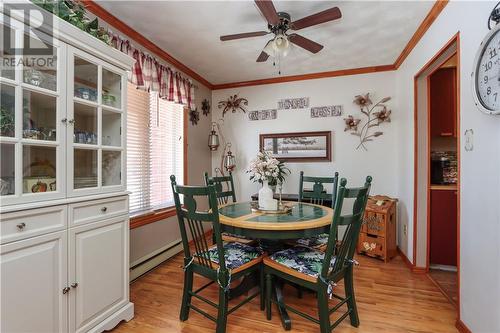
[113, 250, 457, 333]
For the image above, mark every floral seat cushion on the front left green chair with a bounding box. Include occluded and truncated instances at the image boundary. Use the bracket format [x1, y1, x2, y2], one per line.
[201, 242, 262, 270]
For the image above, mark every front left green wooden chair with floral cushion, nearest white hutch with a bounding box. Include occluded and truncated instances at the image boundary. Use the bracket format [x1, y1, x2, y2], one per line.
[170, 175, 264, 333]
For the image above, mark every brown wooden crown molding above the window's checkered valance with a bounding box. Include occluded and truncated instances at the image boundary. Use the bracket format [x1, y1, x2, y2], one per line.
[84, 0, 213, 89]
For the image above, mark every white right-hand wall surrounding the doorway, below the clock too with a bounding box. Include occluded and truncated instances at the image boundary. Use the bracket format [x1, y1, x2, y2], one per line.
[396, 1, 500, 333]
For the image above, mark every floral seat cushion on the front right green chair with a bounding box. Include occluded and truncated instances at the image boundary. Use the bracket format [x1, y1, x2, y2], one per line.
[269, 246, 336, 278]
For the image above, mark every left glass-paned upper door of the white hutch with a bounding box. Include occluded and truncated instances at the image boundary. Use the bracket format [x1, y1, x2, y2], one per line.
[0, 22, 65, 204]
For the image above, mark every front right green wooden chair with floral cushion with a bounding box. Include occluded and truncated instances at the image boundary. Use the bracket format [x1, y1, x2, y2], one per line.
[264, 176, 372, 333]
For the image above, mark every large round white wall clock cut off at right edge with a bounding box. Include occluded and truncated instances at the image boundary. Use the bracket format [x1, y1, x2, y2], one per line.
[472, 17, 500, 115]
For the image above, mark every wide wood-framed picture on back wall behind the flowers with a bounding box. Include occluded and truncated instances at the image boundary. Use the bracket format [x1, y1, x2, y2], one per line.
[259, 131, 332, 162]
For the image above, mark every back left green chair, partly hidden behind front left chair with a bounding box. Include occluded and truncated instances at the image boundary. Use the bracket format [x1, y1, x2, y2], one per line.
[205, 172, 255, 245]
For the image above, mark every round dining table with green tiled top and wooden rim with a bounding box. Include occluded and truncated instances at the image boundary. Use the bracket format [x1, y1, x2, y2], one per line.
[219, 201, 333, 330]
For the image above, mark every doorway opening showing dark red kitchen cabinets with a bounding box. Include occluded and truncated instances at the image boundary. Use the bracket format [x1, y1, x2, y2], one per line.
[427, 52, 458, 305]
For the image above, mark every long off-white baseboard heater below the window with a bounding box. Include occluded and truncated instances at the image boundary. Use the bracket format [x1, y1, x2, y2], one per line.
[130, 239, 182, 282]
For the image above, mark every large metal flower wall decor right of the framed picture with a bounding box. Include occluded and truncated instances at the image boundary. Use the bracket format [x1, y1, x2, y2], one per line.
[344, 93, 391, 150]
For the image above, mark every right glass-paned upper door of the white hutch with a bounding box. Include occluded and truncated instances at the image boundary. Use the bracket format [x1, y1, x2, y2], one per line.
[68, 47, 126, 196]
